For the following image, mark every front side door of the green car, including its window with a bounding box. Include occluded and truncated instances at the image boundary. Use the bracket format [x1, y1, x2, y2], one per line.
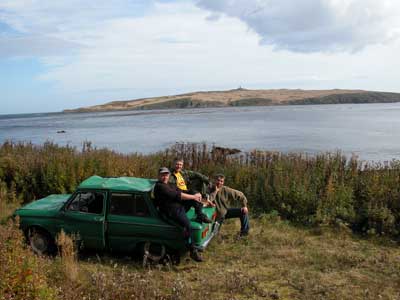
[62, 190, 107, 250]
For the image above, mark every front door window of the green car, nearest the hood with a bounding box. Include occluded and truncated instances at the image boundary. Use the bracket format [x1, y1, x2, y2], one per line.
[67, 191, 104, 214]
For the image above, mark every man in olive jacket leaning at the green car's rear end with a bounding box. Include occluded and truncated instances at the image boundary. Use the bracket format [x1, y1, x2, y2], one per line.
[209, 174, 250, 236]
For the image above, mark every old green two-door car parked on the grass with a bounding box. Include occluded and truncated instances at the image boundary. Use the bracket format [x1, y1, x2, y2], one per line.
[15, 176, 218, 261]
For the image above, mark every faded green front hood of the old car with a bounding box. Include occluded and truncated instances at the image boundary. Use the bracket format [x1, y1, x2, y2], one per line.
[15, 194, 71, 215]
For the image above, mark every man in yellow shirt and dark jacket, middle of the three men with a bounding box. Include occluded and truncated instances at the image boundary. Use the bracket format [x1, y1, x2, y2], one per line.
[169, 158, 210, 197]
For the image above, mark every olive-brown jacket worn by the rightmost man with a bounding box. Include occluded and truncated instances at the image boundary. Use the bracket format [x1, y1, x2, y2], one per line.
[209, 186, 247, 217]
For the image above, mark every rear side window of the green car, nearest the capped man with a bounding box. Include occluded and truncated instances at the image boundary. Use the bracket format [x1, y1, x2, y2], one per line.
[110, 193, 150, 217]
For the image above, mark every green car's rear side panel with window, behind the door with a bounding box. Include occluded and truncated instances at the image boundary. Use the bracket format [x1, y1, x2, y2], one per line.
[107, 192, 180, 252]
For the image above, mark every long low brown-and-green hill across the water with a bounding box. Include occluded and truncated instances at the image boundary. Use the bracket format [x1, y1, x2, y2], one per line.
[64, 88, 400, 112]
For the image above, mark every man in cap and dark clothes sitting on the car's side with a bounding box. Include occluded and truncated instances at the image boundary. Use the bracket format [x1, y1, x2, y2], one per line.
[154, 167, 211, 262]
